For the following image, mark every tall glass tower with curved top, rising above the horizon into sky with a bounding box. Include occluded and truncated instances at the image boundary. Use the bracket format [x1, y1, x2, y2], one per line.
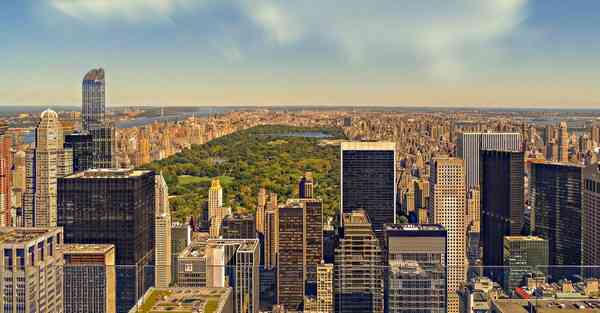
[81, 68, 106, 130]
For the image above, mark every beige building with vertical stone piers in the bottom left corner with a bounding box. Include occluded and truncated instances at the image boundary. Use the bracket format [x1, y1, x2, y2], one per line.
[0, 227, 64, 313]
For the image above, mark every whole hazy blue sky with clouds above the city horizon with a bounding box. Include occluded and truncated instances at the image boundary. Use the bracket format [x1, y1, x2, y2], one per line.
[0, 0, 600, 108]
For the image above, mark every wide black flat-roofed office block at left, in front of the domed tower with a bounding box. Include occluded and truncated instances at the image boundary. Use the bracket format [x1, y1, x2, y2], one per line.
[58, 169, 156, 312]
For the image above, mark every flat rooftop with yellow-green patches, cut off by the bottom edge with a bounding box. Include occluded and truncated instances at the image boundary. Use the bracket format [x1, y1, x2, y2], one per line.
[129, 288, 231, 313]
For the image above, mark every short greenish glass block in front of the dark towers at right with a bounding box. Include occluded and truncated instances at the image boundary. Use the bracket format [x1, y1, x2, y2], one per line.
[504, 236, 549, 290]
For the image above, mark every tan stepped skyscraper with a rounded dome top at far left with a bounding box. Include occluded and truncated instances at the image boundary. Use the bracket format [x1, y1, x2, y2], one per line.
[23, 110, 73, 227]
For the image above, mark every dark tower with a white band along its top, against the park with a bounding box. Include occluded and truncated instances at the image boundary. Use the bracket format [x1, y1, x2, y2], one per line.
[340, 142, 396, 234]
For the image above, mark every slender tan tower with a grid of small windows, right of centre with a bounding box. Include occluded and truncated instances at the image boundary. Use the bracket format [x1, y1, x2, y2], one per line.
[429, 158, 467, 313]
